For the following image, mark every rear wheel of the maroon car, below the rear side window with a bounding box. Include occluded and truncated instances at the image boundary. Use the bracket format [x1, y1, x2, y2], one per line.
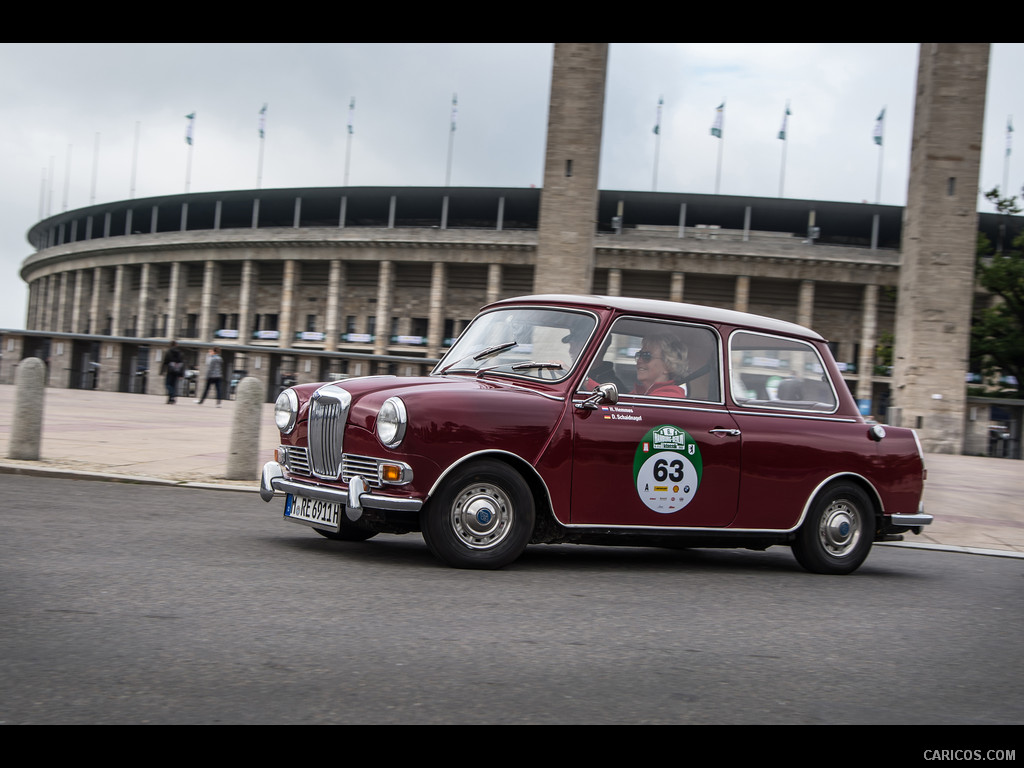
[792, 483, 874, 574]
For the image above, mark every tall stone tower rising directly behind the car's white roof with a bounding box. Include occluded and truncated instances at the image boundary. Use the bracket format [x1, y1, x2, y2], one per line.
[534, 43, 608, 294]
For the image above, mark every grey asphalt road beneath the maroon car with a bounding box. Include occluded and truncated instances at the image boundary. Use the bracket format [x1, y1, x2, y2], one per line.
[0, 475, 1024, 725]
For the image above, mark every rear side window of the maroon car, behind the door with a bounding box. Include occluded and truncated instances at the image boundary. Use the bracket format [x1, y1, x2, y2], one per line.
[729, 331, 838, 413]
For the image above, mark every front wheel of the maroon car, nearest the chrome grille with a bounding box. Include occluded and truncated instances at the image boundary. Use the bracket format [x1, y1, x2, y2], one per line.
[421, 460, 536, 569]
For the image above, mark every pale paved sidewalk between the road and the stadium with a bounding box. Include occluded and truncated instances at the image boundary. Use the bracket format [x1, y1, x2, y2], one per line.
[0, 385, 1024, 556]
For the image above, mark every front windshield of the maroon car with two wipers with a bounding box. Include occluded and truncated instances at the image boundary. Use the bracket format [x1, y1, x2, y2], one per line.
[434, 307, 597, 381]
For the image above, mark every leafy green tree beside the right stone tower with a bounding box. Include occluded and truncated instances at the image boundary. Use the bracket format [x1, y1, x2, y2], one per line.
[971, 187, 1024, 397]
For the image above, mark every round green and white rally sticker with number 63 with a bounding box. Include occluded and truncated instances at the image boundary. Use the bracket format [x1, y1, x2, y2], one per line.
[633, 424, 703, 514]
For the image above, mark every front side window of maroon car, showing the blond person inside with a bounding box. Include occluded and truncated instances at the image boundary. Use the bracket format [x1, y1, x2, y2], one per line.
[582, 317, 722, 402]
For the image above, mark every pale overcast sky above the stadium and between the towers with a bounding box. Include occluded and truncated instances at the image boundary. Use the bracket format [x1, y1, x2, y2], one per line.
[0, 43, 1024, 329]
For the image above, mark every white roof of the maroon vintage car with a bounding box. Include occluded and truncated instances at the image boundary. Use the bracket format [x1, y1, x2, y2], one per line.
[488, 294, 824, 341]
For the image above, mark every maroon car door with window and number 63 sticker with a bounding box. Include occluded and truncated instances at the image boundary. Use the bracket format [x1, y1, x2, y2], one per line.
[570, 317, 741, 527]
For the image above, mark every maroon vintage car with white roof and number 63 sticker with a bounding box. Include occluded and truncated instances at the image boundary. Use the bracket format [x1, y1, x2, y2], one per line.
[260, 295, 932, 573]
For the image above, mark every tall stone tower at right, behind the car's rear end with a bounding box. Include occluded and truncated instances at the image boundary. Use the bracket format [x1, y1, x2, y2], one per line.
[893, 43, 989, 454]
